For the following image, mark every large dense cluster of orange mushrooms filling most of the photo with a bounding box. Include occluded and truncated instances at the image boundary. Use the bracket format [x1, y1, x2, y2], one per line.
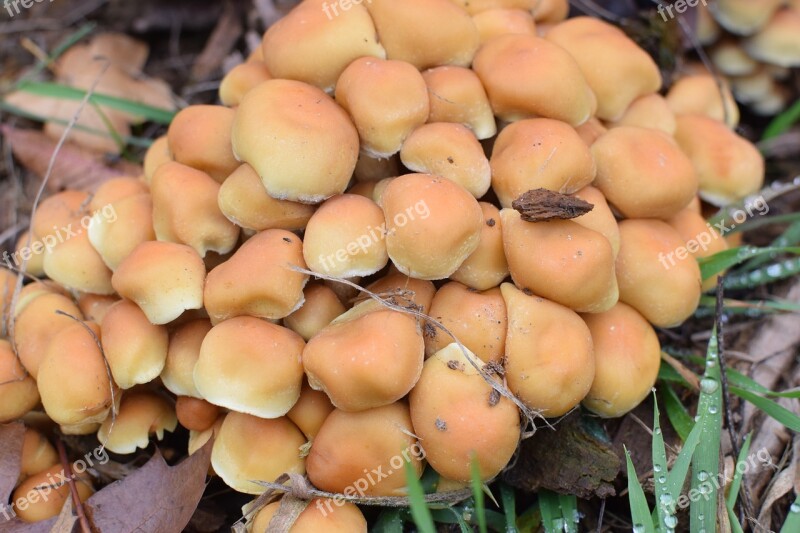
[0, 0, 764, 531]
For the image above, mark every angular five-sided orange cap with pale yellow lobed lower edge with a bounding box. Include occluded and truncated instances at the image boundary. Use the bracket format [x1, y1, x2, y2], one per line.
[111, 241, 206, 324]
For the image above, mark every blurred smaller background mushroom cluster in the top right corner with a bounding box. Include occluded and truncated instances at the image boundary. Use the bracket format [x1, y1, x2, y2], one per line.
[696, 0, 800, 116]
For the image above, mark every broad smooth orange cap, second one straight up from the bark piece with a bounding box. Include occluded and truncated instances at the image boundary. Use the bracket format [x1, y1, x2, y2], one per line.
[472, 34, 594, 126]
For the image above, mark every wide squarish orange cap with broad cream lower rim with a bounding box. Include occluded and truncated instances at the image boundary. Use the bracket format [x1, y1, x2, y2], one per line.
[194, 316, 305, 418]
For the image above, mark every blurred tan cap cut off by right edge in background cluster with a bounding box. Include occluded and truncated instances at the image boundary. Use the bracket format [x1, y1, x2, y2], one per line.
[744, 9, 800, 67]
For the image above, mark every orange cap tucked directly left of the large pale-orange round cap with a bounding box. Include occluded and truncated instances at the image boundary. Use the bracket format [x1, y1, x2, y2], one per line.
[167, 105, 239, 183]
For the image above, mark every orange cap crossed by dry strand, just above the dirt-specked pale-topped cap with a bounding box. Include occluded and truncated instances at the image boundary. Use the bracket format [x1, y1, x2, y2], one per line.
[423, 281, 508, 364]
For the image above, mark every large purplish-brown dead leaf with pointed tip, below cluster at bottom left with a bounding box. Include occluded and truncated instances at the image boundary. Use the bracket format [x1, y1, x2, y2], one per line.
[84, 442, 211, 533]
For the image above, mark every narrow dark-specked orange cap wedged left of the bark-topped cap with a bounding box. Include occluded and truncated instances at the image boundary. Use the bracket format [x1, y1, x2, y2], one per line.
[450, 202, 508, 291]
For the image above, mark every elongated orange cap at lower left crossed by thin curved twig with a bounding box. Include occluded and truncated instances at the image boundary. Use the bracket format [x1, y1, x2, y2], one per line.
[37, 322, 116, 426]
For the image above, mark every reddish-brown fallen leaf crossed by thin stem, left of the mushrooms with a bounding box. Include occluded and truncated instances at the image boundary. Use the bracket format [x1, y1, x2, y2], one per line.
[0, 125, 142, 192]
